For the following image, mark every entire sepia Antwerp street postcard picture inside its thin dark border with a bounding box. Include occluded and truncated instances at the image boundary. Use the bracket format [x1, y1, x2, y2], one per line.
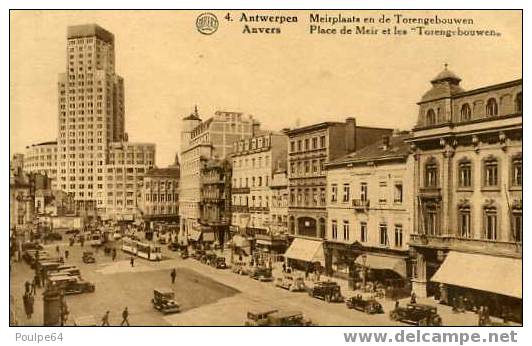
[6, 10, 524, 332]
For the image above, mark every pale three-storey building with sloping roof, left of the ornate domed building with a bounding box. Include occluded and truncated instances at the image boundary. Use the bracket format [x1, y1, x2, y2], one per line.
[325, 134, 414, 287]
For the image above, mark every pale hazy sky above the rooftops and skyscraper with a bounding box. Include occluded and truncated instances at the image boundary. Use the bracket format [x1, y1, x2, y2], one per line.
[10, 10, 522, 167]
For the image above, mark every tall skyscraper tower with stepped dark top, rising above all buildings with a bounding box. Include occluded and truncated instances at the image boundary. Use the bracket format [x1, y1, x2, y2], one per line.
[57, 24, 125, 209]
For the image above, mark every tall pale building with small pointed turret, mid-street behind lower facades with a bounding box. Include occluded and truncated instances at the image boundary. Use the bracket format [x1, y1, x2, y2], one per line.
[179, 107, 260, 243]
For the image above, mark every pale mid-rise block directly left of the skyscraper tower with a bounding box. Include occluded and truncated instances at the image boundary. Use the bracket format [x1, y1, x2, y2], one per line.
[24, 141, 58, 190]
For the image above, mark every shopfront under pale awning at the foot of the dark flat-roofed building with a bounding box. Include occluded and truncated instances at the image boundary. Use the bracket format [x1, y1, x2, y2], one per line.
[284, 238, 325, 272]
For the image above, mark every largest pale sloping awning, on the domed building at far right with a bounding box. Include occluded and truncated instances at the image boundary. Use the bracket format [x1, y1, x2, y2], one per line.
[430, 251, 523, 299]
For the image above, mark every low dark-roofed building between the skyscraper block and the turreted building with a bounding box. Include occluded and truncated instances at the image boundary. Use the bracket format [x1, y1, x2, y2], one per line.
[140, 166, 179, 222]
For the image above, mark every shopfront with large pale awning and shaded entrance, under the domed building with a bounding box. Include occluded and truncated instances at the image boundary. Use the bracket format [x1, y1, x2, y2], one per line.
[430, 251, 523, 323]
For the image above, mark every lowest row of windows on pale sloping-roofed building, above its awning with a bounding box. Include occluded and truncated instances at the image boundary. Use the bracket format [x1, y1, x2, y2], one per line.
[331, 220, 403, 247]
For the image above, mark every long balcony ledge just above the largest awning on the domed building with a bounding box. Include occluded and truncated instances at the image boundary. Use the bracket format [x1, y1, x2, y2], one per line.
[410, 234, 523, 257]
